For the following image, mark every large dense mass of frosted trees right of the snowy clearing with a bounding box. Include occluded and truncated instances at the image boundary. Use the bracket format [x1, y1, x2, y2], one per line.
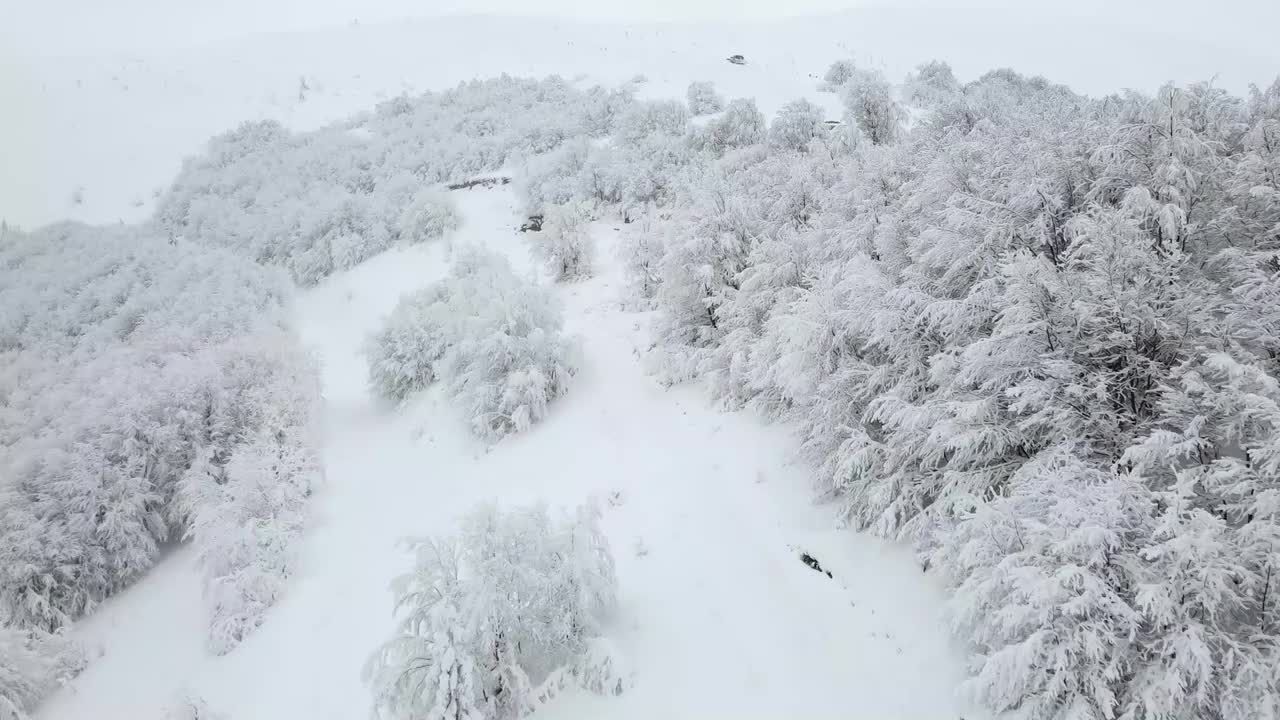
[526, 68, 1280, 720]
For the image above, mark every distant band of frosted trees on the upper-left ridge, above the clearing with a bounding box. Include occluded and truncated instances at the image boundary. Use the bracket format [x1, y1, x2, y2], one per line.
[156, 76, 631, 284]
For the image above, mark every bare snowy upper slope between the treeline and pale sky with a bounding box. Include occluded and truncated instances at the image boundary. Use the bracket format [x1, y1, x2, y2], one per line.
[10, 7, 1280, 227]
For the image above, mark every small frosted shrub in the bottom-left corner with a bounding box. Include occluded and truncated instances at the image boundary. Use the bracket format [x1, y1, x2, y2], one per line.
[0, 625, 86, 720]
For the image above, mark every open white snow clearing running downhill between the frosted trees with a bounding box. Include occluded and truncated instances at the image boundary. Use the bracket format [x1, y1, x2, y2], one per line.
[38, 186, 973, 720]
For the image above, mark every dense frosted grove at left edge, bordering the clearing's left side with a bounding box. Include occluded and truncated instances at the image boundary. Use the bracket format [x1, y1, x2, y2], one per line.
[0, 224, 319, 715]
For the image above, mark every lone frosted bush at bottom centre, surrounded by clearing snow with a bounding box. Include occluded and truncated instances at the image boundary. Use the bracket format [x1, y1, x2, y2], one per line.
[365, 505, 623, 720]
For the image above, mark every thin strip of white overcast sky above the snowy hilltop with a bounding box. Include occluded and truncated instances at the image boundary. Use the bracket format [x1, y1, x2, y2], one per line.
[10, 0, 1280, 55]
